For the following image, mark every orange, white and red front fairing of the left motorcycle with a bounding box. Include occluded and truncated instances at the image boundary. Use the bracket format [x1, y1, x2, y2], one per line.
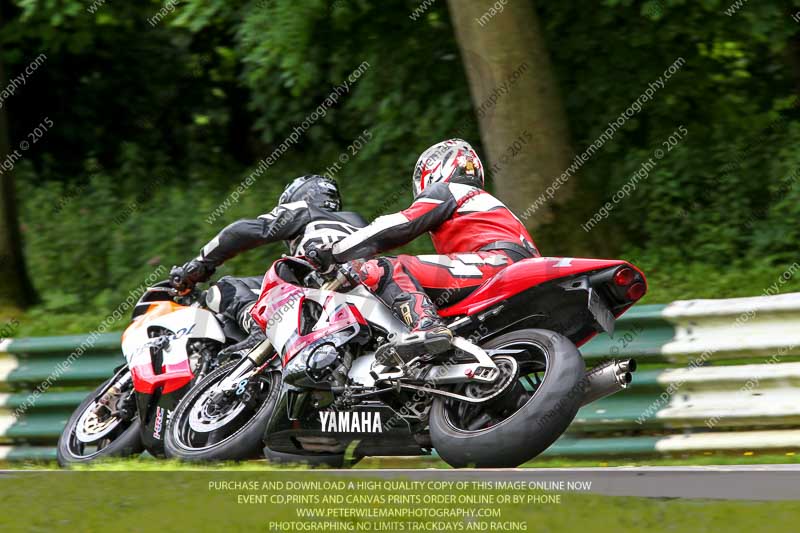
[122, 301, 225, 394]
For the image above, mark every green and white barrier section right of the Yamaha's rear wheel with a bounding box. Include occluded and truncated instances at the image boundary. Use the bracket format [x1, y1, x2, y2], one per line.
[545, 293, 800, 456]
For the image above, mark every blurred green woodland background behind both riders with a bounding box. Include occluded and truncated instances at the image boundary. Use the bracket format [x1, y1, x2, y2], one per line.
[0, 0, 800, 334]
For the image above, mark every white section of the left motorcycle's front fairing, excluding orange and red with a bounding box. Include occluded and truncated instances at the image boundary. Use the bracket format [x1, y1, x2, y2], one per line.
[122, 307, 225, 366]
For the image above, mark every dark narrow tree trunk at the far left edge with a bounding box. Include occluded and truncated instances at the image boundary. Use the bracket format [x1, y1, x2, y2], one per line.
[0, 6, 36, 307]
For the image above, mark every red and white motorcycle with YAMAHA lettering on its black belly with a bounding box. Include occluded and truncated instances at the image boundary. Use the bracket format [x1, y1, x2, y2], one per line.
[166, 254, 647, 467]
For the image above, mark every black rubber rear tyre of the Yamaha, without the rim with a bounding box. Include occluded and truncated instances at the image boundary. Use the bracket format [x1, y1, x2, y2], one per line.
[430, 329, 585, 468]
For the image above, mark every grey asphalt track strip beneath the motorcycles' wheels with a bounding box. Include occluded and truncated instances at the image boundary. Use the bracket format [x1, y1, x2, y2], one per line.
[0, 464, 800, 501]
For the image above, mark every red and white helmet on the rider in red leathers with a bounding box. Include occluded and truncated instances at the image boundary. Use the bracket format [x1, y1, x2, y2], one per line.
[413, 139, 483, 197]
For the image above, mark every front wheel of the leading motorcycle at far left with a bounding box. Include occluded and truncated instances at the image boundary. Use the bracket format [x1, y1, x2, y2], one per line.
[56, 374, 144, 466]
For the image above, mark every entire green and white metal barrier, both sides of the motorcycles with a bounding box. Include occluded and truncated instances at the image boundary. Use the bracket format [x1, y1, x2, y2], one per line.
[0, 293, 800, 460]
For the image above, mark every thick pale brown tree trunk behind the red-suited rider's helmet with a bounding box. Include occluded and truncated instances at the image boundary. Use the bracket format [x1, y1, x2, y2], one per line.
[448, 0, 574, 229]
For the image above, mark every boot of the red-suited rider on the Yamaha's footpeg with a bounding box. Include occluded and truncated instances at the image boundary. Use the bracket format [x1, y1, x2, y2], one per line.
[392, 292, 453, 361]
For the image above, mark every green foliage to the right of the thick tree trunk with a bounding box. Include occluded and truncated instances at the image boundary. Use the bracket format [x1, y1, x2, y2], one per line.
[539, 0, 800, 272]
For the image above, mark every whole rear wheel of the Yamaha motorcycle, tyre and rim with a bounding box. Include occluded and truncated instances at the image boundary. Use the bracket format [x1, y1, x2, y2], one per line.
[430, 329, 585, 468]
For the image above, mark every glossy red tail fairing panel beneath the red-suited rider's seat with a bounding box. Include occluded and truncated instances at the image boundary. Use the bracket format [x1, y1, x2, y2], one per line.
[439, 257, 644, 316]
